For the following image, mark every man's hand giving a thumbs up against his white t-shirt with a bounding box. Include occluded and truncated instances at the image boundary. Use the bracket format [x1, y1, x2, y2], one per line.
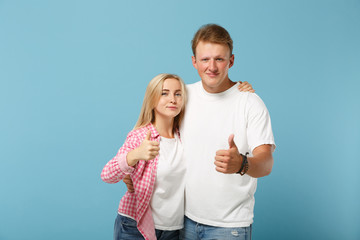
[214, 134, 242, 173]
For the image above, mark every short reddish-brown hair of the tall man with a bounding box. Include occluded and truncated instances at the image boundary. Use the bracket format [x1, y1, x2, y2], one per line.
[191, 24, 233, 56]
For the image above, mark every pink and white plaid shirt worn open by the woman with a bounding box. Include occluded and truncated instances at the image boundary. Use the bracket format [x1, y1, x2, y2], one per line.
[101, 124, 160, 240]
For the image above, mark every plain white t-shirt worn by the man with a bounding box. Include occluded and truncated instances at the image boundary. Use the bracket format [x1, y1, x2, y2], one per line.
[181, 82, 274, 227]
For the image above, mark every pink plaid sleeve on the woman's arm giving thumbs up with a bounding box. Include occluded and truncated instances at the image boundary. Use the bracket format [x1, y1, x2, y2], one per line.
[101, 131, 141, 183]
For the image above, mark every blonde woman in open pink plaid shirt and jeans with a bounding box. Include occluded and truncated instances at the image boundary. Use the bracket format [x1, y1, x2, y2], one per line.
[101, 74, 253, 240]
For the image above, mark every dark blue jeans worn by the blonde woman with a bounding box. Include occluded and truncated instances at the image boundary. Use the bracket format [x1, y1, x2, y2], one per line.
[114, 214, 180, 240]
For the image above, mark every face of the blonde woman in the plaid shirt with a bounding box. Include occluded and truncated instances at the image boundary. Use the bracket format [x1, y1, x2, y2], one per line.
[154, 78, 183, 119]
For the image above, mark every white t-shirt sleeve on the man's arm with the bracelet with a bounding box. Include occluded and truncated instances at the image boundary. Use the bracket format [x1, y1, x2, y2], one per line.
[246, 93, 275, 151]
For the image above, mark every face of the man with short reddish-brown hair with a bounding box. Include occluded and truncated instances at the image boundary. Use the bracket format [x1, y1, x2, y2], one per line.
[192, 41, 234, 93]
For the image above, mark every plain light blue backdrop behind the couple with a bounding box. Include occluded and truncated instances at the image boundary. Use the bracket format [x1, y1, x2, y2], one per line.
[0, 0, 360, 240]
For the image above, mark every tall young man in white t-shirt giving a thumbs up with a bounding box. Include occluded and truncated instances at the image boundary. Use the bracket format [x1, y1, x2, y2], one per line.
[180, 24, 275, 240]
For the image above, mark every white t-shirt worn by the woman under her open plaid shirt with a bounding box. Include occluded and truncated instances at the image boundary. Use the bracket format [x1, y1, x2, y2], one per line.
[150, 134, 186, 230]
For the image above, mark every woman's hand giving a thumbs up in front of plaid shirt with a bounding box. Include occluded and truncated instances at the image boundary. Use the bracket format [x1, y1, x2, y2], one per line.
[126, 130, 160, 166]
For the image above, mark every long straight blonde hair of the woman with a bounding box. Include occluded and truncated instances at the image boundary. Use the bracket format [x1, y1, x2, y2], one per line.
[134, 73, 187, 132]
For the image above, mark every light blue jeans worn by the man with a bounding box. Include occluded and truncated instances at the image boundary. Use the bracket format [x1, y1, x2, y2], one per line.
[180, 216, 252, 240]
